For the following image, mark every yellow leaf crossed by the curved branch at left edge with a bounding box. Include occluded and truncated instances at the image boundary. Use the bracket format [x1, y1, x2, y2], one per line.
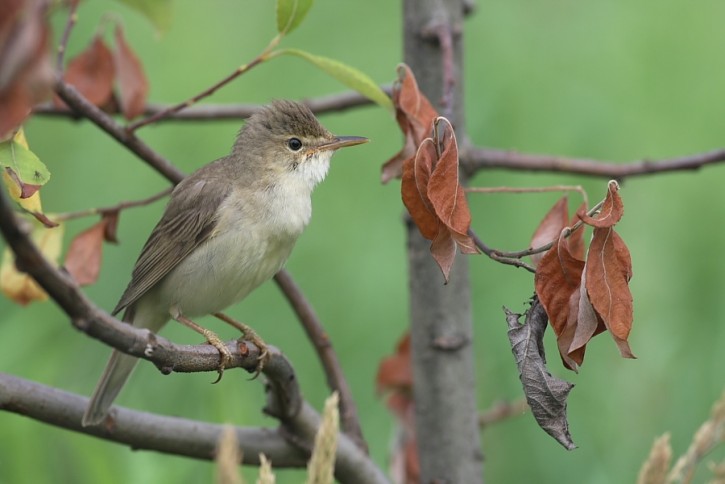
[0, 221, 64, 305]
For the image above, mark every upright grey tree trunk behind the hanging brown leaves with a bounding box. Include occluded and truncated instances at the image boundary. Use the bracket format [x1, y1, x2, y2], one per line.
[403, 0, 483, 483]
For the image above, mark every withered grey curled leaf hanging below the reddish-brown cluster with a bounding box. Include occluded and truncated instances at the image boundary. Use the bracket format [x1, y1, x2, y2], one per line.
[503, 297, 576, 450]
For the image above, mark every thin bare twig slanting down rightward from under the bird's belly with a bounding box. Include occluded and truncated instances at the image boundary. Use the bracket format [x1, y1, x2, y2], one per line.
[274, 271, 368, 453]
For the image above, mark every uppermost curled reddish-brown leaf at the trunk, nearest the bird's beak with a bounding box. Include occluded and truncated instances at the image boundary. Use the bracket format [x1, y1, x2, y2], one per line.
[382, 64, 438, 183]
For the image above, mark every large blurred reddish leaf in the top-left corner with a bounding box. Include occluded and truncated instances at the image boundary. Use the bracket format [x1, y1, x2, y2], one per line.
[0, 0, 53, 140]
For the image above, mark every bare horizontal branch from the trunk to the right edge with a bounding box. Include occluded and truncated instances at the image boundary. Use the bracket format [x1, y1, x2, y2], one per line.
[461, 148, 725, 180]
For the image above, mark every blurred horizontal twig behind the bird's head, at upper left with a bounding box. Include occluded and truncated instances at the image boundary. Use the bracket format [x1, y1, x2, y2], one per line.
[33, 85, 392, 123]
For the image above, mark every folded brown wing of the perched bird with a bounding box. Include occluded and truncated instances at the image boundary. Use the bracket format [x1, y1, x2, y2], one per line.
[112, 175, 228, 315]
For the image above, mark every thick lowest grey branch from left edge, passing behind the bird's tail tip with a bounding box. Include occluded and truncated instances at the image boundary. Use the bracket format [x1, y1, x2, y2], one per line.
[0, 372, 387, 484]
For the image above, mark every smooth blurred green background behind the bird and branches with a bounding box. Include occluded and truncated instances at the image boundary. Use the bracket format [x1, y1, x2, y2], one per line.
[0, 0, 725, 484]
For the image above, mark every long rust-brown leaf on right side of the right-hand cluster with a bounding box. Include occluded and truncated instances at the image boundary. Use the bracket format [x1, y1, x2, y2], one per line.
[586, 227, 635, 358]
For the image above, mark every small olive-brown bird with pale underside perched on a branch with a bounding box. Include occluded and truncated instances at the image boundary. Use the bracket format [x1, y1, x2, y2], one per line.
[81, 100, 369, 426]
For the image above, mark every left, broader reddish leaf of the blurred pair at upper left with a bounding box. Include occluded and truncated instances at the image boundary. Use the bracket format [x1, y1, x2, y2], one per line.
[56, 35, 115, 106]
